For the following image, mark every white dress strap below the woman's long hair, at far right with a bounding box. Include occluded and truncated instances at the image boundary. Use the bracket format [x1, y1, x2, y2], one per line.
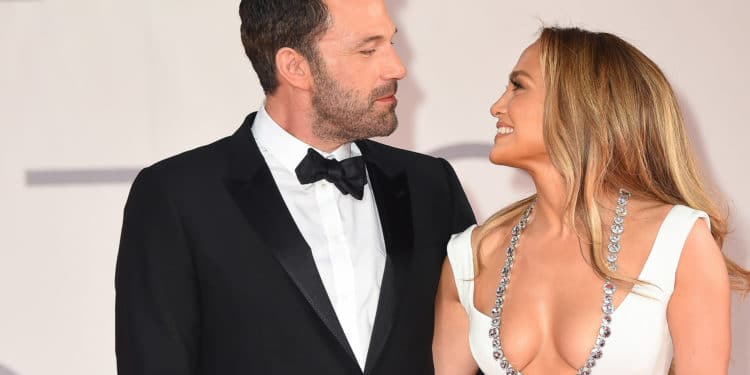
[634, 205, 711, 300]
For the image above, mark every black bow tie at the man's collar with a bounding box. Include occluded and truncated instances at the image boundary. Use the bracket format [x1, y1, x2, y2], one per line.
[294, 148, 367, 199]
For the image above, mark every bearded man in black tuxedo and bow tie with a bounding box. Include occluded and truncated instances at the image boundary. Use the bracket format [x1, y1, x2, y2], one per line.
[115, 0, 474, 375]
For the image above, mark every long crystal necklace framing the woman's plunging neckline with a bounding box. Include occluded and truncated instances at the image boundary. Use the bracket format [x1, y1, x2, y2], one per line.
[490, 189, 630, 375]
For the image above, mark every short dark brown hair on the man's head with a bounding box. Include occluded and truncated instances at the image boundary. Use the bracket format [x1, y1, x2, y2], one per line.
[240, 0, 329, 94]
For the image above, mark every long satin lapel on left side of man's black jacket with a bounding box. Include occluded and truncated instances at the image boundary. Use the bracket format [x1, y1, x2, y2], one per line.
[226, 114, 356, 361]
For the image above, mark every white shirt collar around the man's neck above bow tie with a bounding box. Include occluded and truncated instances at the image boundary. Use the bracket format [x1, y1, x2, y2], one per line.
[251, 105, 362, 178]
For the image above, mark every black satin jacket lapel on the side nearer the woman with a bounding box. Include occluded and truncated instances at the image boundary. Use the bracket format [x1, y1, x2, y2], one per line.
[357, 141, 414, 374]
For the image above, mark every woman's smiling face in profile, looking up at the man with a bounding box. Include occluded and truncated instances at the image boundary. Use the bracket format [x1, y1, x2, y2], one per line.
[490, 42, 549, 169]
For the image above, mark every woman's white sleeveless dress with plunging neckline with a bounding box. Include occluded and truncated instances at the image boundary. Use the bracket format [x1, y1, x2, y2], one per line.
[448, 205, 710, 375]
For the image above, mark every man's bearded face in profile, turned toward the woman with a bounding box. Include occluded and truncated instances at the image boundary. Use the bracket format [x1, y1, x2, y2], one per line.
[311, 0, 406, 142]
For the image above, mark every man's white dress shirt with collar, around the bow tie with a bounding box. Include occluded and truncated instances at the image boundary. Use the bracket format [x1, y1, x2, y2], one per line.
[252, 108, 386, 369]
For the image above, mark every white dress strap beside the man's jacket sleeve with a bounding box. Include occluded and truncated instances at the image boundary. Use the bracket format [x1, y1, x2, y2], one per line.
[447, 224, 476, 314]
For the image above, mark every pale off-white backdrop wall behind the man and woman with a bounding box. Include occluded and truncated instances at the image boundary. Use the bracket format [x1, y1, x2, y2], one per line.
[0, 0, 750, 375]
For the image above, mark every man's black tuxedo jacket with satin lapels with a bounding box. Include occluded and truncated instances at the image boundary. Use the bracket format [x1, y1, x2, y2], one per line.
[115, 114, 475, 375]
